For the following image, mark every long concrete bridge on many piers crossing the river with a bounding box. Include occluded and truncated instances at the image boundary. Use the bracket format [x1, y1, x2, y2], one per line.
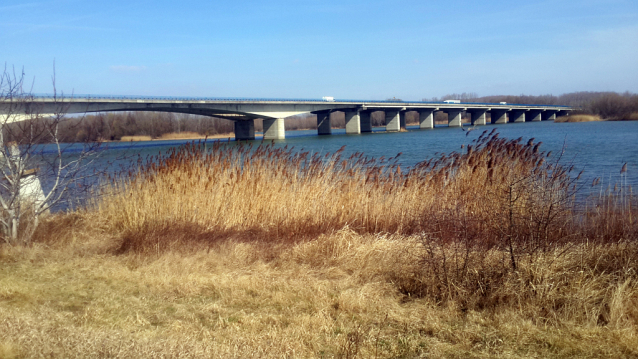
[0, 95, 573, 140]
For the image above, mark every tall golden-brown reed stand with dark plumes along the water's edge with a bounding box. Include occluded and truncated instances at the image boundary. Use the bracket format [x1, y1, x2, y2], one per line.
[95, 131, 584, 256]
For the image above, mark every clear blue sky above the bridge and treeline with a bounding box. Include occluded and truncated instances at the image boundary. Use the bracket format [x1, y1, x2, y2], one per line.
[0, 0, 638, 100]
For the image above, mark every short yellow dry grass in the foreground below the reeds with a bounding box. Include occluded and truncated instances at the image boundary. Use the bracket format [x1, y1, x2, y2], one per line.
[0, 228, 638, 358]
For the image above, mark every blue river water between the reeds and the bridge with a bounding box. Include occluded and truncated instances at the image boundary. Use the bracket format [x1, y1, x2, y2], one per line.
[97, 121, 638, 184]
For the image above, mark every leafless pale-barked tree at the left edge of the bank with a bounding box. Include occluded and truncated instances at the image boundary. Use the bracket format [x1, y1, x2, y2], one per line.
[0, 65, 100, 244]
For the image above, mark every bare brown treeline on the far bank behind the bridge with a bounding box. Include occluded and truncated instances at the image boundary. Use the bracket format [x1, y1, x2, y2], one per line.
[9, 92, 638, 142]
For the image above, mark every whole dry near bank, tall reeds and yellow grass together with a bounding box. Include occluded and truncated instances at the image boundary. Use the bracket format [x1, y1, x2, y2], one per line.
[0, 132, 638, 358]
